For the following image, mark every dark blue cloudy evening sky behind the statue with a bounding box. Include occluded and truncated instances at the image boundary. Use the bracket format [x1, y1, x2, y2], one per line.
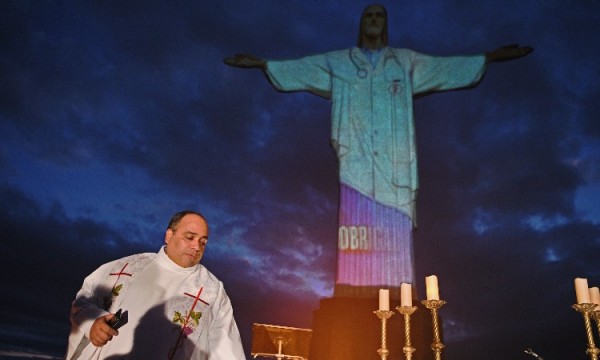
[0, 0, 600, 360]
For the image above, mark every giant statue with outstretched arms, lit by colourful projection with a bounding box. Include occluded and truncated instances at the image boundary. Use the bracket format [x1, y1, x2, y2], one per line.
[224, 5, 532, 297]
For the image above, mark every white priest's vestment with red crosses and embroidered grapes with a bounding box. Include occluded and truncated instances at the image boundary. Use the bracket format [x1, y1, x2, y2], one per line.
[66, 249, 245, 360]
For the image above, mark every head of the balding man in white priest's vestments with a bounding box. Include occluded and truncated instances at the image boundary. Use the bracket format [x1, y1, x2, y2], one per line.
[165, 214, 208, 268]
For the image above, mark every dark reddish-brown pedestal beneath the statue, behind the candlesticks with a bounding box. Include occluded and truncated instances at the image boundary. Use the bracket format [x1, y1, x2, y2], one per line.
[309, 297, 433, 360]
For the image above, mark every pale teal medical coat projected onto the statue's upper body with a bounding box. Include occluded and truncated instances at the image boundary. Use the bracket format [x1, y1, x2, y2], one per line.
[266, 48, 485, 222]
